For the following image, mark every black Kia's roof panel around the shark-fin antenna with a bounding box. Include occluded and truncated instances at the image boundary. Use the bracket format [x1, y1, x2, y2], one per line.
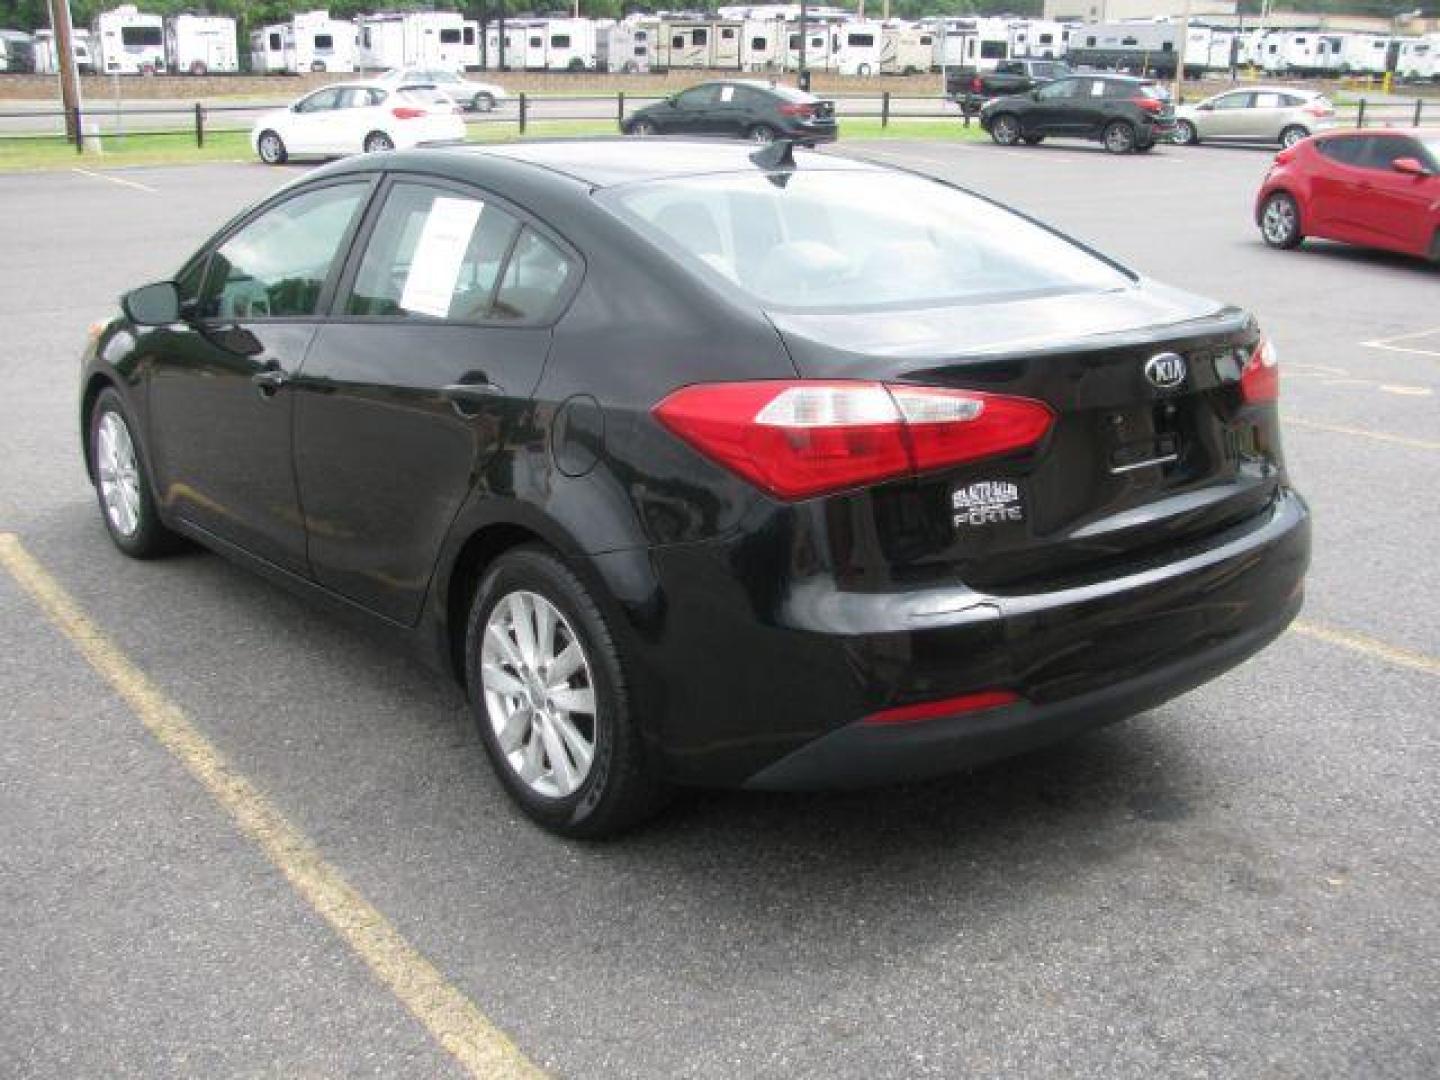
[432, 137, 881, 187]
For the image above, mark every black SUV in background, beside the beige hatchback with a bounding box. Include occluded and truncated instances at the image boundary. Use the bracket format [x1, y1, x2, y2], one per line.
[981, 75, 1175, 154]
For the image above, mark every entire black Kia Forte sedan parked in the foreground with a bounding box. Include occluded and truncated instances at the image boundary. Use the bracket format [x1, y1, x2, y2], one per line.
[81, 140, 1309, 835]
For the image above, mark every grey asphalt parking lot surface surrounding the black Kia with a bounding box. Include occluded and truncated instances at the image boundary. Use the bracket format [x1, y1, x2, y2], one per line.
[0, 143, 1440, 1077]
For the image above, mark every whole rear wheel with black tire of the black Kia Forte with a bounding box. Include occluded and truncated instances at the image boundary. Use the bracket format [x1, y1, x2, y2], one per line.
[465, 546, 665, 838]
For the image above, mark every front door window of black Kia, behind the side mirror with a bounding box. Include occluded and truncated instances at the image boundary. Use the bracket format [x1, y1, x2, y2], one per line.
[200, 181, 370, 320]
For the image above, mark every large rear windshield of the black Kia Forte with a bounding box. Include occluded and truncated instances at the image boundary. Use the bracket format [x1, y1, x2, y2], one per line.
[598, 170, 1130, 308]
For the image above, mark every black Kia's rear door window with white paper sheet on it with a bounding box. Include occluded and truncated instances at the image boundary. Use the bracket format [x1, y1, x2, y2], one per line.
[344, 183, 520, 323]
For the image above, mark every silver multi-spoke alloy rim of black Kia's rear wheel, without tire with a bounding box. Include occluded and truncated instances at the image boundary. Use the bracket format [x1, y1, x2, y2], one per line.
[480, 590, 598, 799]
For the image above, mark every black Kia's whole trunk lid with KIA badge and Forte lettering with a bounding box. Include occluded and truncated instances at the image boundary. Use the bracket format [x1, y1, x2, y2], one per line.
[770, 284, 1282, 592]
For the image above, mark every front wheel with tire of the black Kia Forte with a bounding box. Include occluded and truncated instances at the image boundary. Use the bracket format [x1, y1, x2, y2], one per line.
[89, 389, 179, 559]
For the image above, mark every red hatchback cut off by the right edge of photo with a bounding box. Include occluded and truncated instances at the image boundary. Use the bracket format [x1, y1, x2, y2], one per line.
[1256, 128, 1440, 262]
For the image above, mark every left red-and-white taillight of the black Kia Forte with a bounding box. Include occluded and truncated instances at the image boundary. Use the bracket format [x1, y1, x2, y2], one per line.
[655, 382, 1053, 500]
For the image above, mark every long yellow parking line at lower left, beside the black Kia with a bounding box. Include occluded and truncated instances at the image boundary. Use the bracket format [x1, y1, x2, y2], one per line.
[0, 533, 544, 1079]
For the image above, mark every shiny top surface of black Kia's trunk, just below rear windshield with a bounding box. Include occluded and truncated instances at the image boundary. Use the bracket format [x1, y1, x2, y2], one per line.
[766, 281, 1247, 377]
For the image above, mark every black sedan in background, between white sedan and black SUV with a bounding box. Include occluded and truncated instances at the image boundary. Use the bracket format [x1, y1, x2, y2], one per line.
[621, 79, 835, 144]
